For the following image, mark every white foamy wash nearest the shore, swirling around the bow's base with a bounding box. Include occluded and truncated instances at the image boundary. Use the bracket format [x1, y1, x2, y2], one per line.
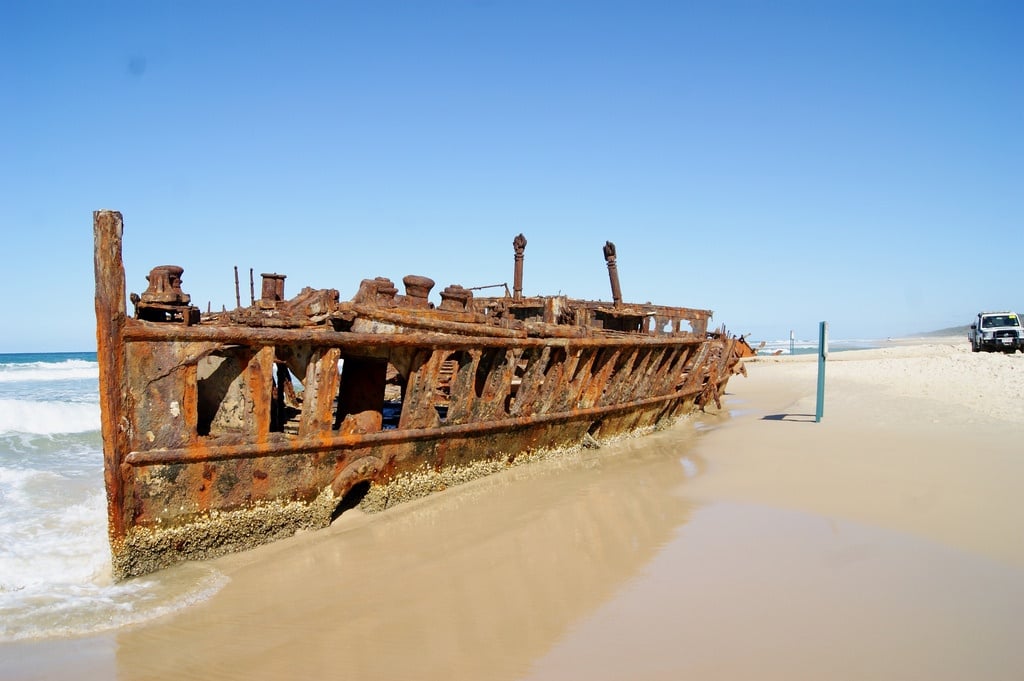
[0, 460, 227, 641]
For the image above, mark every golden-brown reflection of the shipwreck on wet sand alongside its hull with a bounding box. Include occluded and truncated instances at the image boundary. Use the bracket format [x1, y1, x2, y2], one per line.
[117, 425, 700, 679]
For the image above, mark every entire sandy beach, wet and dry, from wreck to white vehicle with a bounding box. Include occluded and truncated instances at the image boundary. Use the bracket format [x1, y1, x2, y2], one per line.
[0, 338, 1024, 681]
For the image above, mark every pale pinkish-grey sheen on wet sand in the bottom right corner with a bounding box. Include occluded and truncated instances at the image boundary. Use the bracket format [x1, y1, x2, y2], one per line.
[521, 502, 1024, 681]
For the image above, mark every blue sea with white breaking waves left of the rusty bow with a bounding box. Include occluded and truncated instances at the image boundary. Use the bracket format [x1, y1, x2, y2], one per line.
[0, 352, 224, 641]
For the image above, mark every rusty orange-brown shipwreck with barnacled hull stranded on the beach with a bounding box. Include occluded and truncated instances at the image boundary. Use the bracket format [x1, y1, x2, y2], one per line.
[93, 211, 742, 579]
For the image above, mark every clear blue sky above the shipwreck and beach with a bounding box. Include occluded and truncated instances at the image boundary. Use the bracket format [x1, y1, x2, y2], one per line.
[0, 0, 1024, 351]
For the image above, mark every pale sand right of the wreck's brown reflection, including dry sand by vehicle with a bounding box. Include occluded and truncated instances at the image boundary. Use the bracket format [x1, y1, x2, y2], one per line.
[525, 339, 1024, 681]
